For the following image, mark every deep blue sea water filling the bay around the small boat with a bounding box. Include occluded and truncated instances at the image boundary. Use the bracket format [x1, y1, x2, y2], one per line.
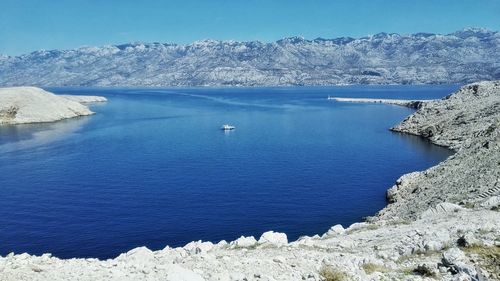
[0, 86, 458, 258]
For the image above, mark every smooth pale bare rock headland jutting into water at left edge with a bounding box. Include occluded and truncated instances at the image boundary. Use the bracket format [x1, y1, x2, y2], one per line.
[0, 87, 106, 125]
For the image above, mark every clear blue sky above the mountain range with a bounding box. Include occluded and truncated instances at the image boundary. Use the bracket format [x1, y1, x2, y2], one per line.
[0, 0, 500, 55]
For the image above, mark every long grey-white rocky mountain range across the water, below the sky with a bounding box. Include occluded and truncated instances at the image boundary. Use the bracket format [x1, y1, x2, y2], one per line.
[0, 29, 500, 86]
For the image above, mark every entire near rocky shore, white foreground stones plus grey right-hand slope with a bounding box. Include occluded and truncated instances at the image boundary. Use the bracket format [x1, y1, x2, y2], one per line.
[0, 82, 500, 281]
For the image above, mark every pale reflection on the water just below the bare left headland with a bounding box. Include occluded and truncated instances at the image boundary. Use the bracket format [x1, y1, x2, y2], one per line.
[0, 116, 91, 153]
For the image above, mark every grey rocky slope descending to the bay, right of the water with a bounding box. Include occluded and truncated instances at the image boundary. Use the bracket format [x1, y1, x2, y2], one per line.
[378, 81, 500, 219]
